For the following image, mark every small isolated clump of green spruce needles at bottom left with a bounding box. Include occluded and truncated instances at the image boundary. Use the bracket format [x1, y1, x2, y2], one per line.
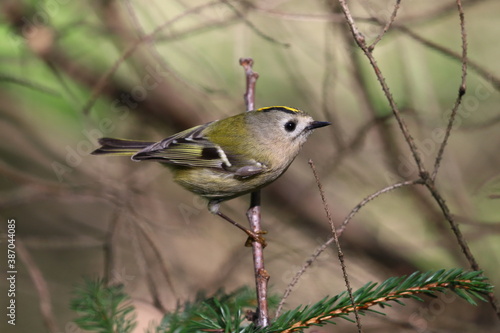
[71, 279, 136, 333]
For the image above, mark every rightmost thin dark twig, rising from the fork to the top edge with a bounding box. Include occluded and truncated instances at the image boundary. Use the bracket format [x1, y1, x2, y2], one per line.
[431, 0, 467, 181]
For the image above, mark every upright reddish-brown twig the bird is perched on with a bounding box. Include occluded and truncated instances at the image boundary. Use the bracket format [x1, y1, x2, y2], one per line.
[240, 58, 270, 327]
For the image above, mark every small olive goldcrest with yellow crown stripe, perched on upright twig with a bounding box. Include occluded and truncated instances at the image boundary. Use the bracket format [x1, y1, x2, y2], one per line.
[92, 106, 330, 242]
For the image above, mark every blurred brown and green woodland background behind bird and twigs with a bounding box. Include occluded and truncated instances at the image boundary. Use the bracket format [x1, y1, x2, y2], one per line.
[0, 0, 500, 332]
